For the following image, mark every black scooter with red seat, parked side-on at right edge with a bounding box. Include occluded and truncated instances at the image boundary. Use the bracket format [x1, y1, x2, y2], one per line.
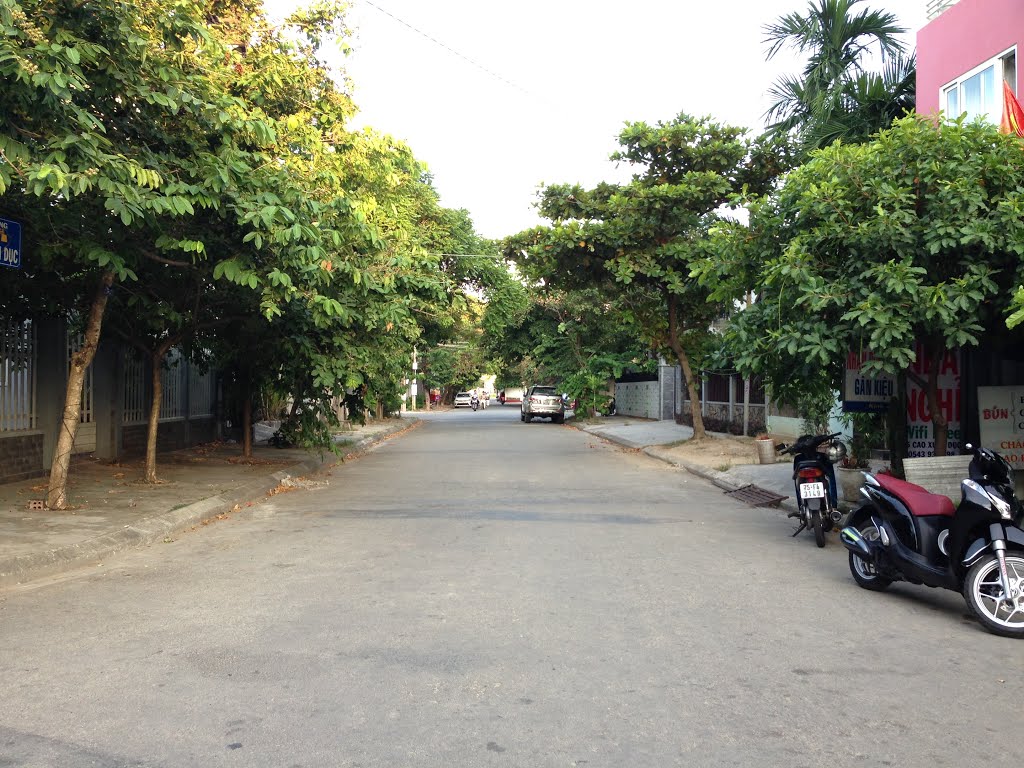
[840, 444, 1024, 637]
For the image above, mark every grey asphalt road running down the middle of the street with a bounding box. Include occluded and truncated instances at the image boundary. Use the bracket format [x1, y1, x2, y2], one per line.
[0, 407, 1024, 768]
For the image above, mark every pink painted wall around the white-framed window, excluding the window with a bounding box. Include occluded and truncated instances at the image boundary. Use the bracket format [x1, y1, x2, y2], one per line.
[918, 0, 1024, 115]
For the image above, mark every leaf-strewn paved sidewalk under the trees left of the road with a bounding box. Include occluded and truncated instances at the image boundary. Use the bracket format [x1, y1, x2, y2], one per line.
[0, 418, 419, 588]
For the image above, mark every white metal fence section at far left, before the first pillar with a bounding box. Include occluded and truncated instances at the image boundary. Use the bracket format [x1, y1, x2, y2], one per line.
[0, 318, 37, 432]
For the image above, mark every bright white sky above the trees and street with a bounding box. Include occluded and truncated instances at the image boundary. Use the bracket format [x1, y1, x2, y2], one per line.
[266, 0, 926, 238]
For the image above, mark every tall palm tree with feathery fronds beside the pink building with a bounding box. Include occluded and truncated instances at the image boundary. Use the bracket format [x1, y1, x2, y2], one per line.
[765, 0, 915, 151]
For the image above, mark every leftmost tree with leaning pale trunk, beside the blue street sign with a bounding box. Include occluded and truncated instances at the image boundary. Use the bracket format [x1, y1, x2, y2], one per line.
[0, 0, 288, 509]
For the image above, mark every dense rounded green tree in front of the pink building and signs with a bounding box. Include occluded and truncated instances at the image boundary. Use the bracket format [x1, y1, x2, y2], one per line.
[696, 118, 1024, 455]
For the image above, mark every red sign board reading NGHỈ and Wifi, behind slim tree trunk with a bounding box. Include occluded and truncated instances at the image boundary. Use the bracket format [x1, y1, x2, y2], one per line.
[906, 343, 961, 458]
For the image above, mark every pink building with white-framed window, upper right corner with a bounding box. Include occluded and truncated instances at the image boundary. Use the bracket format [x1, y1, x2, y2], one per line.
[918, 0, 1024, 120]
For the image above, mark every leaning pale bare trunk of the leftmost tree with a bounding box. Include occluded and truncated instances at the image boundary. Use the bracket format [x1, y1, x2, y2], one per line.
[46, 272, 114, 509]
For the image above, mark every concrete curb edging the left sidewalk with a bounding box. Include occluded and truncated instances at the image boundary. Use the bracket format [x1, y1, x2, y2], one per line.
[0, 419, 422, 589]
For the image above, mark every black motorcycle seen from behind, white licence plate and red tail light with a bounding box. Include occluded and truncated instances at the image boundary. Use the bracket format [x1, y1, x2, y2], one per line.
[775, 432, 846, 547]
